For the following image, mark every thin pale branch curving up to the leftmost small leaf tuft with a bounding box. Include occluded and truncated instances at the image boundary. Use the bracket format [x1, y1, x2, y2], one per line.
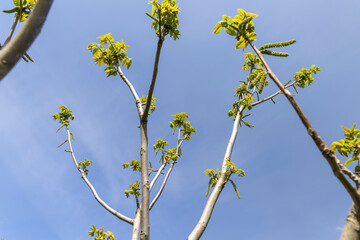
[66, 126, 134, 224]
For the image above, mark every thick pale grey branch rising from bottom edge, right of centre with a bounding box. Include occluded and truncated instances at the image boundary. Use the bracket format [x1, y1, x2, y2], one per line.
[187, 105, 245, 240]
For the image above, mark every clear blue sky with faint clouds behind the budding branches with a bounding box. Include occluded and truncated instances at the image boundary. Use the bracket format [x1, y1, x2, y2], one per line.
[0, 0, 360, 240]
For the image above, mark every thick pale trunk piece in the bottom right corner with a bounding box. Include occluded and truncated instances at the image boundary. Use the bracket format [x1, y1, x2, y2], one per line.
[340, 203, 360, 240]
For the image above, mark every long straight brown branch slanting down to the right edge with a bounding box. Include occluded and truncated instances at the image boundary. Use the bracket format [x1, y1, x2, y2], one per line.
[244, 36, 360, 207]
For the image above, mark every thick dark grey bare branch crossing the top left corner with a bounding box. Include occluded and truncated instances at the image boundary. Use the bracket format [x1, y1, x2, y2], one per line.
[0, 0, 53, 80]
